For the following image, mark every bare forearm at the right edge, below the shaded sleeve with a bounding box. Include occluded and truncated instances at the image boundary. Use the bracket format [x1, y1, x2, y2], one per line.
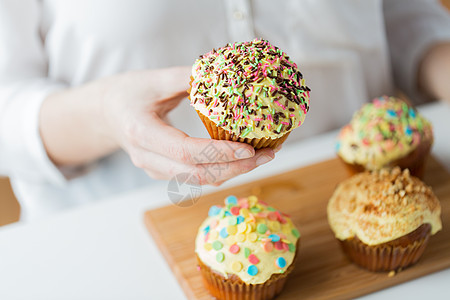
[419, 43, 450, 103]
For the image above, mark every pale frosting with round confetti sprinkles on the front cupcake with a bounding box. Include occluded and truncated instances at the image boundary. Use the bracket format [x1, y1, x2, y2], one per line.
[196, 196, 300, 277]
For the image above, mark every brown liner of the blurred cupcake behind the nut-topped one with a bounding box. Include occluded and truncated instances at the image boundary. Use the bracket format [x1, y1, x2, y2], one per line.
[338, 140, 433, 179]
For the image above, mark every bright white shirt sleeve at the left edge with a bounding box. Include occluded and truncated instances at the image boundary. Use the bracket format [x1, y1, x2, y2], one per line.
[0, 0, 66, 185]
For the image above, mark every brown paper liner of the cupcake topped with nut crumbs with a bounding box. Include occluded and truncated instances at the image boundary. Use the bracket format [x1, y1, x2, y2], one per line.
[339, 224, 431, 272]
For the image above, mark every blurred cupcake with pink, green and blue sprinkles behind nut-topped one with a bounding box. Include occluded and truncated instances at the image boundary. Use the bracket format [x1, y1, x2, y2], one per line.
[336, 96, 433, 178]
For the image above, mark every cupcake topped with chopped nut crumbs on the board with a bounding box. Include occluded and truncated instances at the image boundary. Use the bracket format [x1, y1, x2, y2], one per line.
[327, 167, 442, 271]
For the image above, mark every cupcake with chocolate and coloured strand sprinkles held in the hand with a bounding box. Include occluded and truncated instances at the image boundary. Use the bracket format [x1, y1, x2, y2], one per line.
[189, 39, 310, 149]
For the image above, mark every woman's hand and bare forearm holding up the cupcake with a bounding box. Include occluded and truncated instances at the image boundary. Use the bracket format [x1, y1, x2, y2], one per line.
[41, 67, 274, 184]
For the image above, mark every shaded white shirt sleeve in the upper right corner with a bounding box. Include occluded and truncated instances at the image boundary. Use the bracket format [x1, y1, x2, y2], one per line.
[383, 0, 450, 104]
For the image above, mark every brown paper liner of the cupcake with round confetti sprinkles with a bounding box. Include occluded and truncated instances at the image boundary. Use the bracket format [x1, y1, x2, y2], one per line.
[197, 239, 300, 300]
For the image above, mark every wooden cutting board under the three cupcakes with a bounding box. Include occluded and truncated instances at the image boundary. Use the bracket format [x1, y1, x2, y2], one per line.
[145, 159, 450, 300]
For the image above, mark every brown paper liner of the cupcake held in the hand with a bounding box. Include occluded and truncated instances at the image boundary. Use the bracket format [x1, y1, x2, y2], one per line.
[187, 76, 290, 149]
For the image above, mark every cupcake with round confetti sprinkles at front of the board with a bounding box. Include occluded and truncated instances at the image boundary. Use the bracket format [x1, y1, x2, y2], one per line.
[195, 196, 300, 300]
